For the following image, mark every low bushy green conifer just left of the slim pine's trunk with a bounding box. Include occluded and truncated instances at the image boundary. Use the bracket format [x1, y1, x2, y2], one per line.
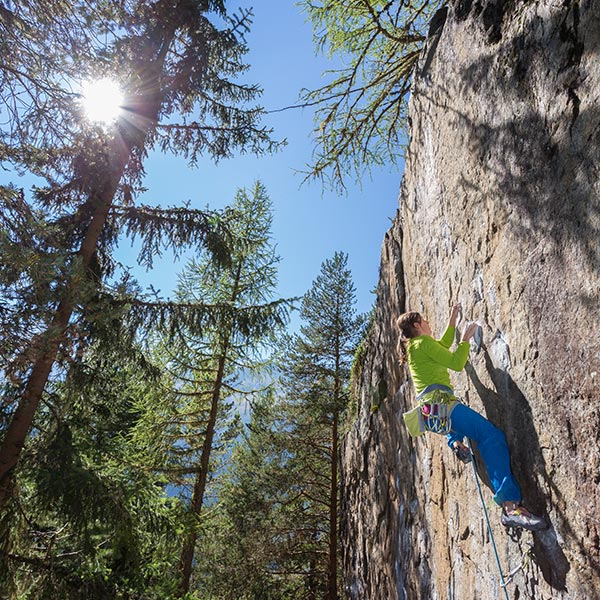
[196, 390, 306, 600]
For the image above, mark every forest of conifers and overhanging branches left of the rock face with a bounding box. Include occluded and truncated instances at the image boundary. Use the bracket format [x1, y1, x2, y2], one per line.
[0, 0, 440, 600]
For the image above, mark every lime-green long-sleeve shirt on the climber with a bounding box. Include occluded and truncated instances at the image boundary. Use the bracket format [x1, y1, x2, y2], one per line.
[407, 327, 470, 394]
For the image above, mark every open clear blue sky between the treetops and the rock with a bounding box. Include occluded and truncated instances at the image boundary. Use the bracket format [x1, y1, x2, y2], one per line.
[122, 0, 401, 324]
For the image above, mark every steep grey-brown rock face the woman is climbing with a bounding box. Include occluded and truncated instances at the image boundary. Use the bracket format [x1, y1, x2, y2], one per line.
[341, 0, 600, 600]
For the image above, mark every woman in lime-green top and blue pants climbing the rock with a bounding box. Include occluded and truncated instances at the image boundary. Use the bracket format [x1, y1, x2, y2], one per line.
[397, 304, 547, 531]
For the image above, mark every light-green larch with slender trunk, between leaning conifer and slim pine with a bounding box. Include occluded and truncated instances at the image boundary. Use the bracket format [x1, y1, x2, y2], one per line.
[131, 183, 289, 595]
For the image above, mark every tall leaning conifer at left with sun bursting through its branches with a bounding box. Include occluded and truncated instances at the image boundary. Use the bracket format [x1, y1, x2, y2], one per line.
[0, 0, 274, 510]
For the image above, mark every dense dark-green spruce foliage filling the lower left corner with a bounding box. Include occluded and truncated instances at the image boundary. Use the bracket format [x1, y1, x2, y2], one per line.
[0, 348, 179, 600]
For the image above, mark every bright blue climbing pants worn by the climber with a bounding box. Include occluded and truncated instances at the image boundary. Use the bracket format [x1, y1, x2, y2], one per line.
[447, 404, 521, 504]
